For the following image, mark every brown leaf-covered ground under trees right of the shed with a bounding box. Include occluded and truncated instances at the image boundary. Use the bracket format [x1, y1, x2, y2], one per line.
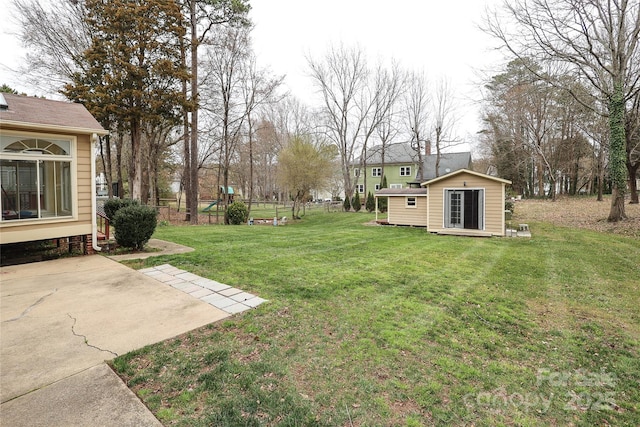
[512, 197, 640, 238]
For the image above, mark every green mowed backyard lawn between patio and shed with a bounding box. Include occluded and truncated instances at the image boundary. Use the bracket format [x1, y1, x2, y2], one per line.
[113, 210, 640, 426]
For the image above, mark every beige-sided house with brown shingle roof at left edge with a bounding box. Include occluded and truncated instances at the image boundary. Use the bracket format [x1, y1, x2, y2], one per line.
[0, 94, 108, 253]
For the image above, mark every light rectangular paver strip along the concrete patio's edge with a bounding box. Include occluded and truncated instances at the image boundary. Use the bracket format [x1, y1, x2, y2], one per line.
[139, 264, 267, 314]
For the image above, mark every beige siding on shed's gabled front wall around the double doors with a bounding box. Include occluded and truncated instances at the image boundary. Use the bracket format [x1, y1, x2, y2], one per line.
[428, 173, 504, 236]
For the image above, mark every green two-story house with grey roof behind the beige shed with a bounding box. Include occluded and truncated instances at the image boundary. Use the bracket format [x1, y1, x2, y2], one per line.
[353, 143, 471, 195]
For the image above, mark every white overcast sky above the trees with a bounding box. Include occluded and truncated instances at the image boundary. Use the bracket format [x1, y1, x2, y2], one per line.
[0, 0, 503, 152]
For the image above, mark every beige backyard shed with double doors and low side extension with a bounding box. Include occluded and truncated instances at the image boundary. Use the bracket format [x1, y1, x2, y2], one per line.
[375, 169, 511, 236]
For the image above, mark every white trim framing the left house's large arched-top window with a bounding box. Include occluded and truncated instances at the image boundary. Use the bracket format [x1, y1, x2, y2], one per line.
[0, 129, 78, 227]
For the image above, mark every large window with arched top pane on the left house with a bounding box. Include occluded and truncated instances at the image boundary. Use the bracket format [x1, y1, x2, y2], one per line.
[0, 135, 73, 221]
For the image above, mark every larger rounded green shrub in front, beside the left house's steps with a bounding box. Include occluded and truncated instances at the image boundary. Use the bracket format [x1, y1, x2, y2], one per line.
[114, 203, 158, 250]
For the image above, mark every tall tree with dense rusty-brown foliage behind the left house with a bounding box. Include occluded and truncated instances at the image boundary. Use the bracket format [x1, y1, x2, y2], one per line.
[63, 0, 189, 202]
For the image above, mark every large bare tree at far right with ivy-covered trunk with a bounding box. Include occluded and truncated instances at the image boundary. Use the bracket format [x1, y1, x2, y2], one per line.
[486, 0, 640, 221]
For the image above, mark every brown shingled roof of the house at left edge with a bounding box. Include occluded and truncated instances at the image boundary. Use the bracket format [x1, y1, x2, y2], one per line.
[0, 93, 107, 135]
